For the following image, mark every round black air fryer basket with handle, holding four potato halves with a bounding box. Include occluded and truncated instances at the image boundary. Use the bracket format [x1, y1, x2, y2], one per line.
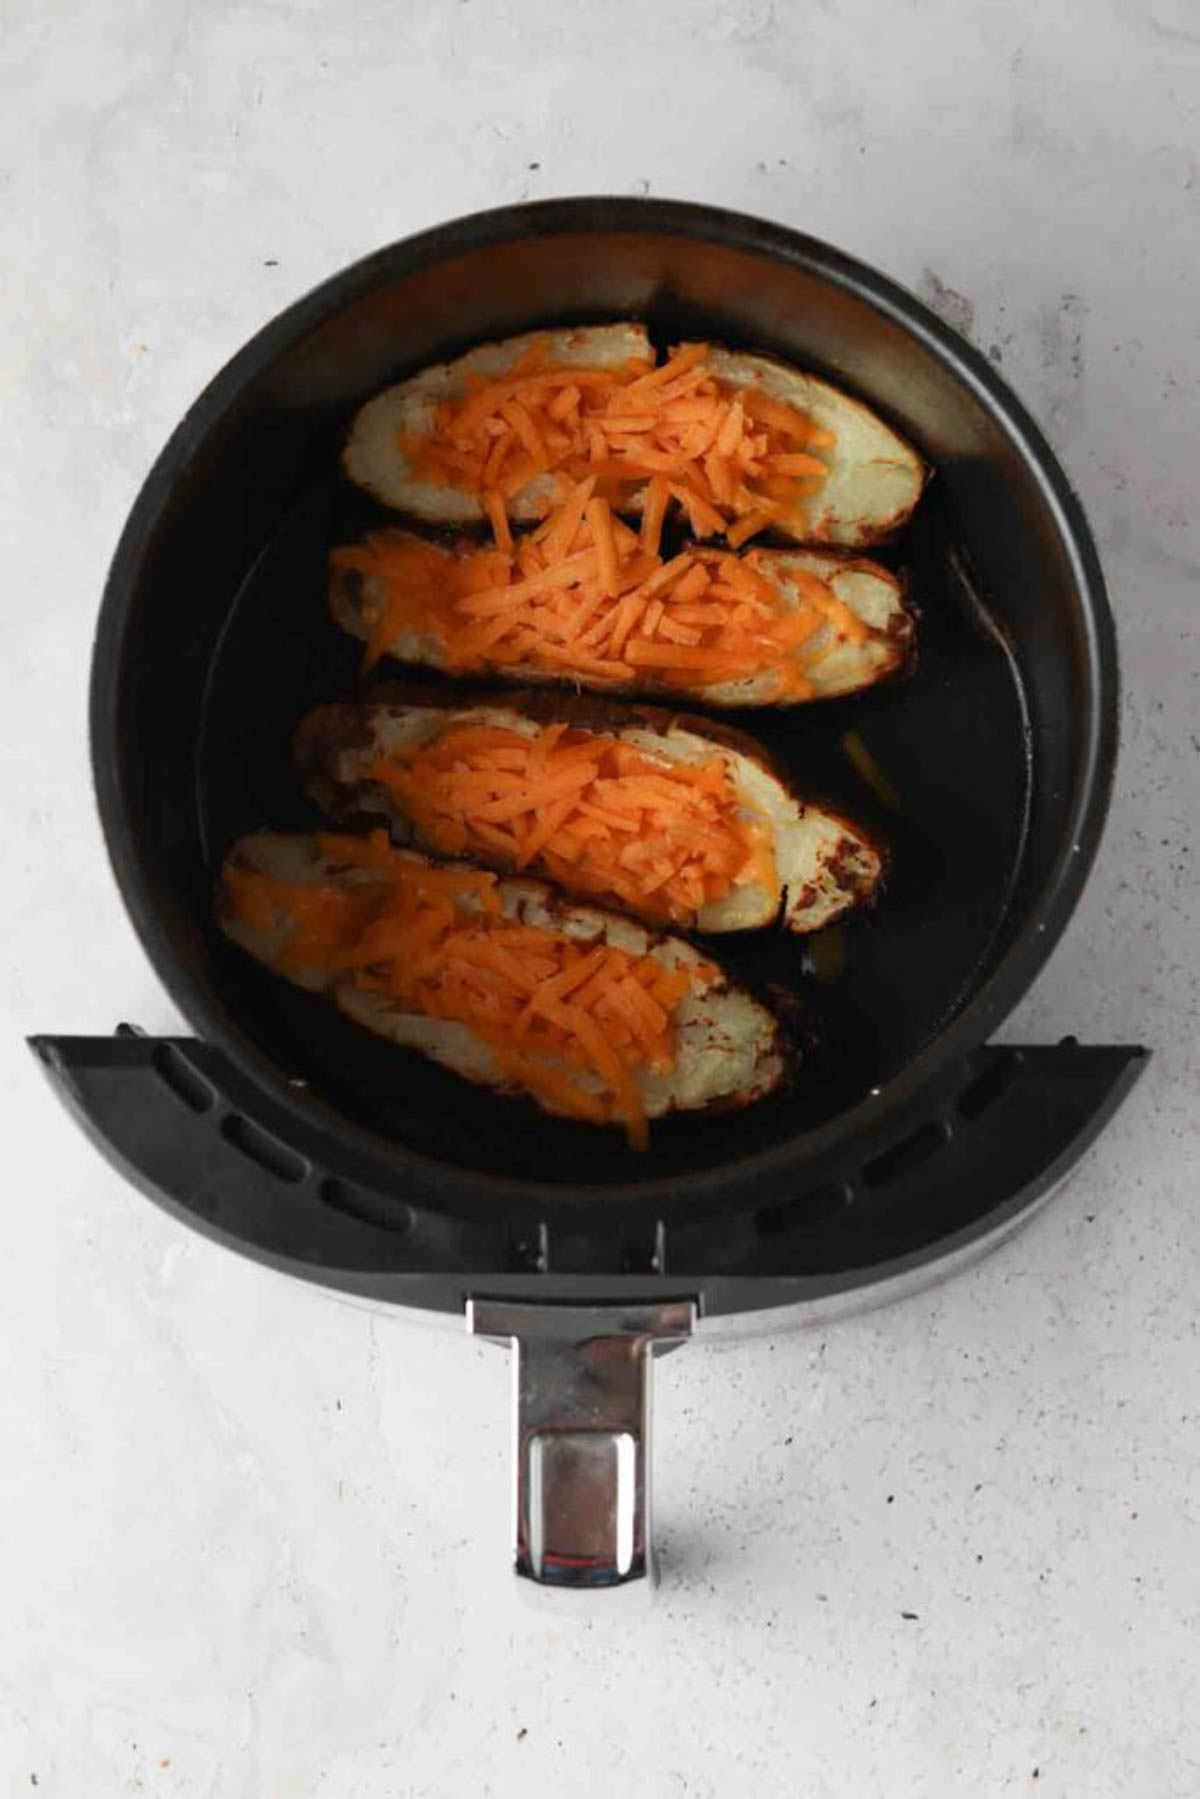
[34, 200, 1142, 1585]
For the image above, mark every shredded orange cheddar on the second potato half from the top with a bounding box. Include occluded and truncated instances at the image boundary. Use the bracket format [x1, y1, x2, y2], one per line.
[331, 475, 869, 700]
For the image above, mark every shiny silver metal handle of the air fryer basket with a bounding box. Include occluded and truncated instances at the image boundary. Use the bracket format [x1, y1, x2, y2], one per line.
[468, 1299, 696, 1587]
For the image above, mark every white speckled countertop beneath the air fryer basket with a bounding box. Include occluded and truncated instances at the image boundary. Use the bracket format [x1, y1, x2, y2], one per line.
[0, 0, 1200, 1799]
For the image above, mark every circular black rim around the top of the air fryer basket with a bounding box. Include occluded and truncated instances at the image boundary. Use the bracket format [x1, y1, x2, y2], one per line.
[90, 196, 1117, 1207]
